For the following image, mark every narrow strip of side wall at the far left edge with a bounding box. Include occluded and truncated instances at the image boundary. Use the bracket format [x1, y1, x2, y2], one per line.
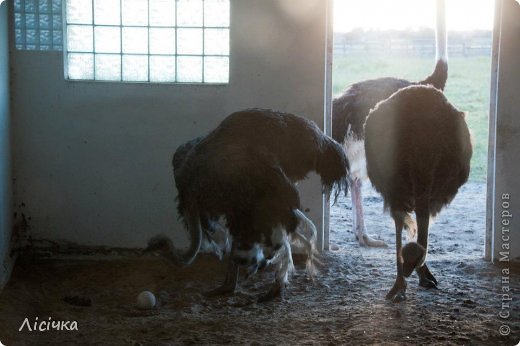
[0, 1, 11, 289]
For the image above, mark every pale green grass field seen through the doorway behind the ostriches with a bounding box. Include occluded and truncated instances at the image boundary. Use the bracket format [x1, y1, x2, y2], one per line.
[332, 55, 491, 181]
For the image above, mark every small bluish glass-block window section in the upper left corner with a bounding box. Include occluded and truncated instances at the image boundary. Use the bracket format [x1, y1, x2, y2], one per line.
[13, 0, 63, 51]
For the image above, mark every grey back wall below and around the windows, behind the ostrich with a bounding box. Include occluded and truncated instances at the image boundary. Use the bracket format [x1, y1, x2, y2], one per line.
[12, 0, 327, 247]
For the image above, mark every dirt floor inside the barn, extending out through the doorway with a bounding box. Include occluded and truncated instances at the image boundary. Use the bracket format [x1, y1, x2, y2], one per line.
[0, 183, 520, 346]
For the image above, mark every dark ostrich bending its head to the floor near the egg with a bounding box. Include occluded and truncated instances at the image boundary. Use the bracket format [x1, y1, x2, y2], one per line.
[148, 109, 349, 300]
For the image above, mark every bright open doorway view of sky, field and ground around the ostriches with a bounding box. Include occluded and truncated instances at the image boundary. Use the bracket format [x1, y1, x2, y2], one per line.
[329, 0, 494, 262]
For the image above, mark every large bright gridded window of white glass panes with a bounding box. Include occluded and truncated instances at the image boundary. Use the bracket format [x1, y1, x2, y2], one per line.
[64, 0, 229, 83]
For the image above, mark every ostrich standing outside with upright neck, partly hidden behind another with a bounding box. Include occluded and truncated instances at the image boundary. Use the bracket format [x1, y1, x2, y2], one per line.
[332, 0, 448, 247]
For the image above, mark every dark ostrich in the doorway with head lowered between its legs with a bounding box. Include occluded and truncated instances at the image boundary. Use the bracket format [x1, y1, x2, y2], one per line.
[365, 86, 472, 302]
